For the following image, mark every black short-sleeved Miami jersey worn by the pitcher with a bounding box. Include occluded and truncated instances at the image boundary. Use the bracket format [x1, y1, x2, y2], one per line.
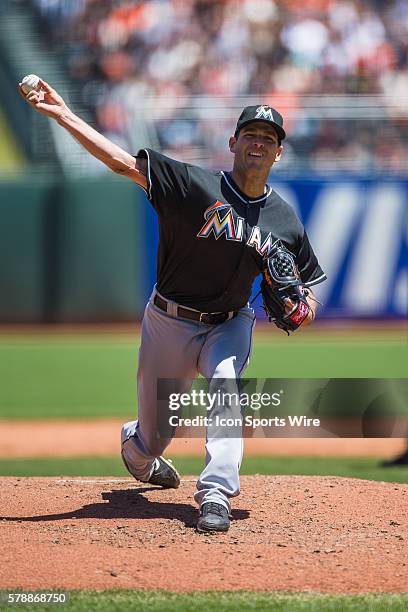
[137, 149, 326, 312]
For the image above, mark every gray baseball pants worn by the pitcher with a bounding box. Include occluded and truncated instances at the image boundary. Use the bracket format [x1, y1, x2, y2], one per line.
[122, 290, 255, 510]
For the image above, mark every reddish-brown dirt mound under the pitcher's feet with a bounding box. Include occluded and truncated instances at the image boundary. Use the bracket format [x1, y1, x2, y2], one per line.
[0, 476, 408, 593]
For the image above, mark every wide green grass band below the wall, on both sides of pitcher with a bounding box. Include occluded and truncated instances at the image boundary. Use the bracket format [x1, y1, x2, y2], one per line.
[0, 331, 408, 420]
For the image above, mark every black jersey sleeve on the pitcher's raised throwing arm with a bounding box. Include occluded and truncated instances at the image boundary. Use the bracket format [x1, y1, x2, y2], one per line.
[136, 149, 190, 215]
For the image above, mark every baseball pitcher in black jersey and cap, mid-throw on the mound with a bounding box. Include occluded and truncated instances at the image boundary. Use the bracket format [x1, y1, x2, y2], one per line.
[20, 80, 326, 532]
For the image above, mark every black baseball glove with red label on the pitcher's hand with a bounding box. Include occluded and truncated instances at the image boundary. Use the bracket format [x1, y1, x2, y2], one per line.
[261, 240, 311, 335]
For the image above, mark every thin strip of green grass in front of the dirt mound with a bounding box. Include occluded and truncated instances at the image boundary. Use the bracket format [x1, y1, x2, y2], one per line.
[2, 590, 408, 612]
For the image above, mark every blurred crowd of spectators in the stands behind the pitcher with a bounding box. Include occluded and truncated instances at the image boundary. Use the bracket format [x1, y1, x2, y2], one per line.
[32, 0, 408, 172]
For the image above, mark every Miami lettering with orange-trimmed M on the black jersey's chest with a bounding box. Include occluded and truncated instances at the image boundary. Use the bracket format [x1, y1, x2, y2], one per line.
[197, 200, 273, 256]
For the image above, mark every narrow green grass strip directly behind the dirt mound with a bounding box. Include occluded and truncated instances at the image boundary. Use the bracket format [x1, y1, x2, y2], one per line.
[0, 455, 408, 483]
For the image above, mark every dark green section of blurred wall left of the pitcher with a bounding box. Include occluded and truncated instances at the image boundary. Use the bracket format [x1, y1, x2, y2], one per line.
[0, 176, 145, 323]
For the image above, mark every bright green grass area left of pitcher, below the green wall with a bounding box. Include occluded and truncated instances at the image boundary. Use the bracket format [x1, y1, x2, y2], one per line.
[0, 336, 138, 419]
